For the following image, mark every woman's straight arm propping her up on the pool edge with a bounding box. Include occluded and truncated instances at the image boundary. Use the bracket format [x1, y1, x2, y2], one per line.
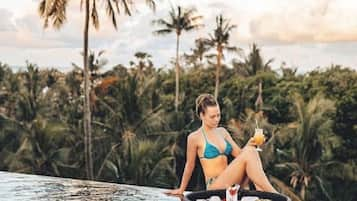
[167, 135, 197, 195]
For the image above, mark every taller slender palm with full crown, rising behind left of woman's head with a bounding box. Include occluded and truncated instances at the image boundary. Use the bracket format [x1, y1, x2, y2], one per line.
[153, 6, 203, 112]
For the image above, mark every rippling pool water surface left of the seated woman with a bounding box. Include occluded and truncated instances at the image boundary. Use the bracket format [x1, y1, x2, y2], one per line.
[0, 171, 182, 201]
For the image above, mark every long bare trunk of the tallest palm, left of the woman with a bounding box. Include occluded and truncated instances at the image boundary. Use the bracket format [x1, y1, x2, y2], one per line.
[83, 0, 93, 179]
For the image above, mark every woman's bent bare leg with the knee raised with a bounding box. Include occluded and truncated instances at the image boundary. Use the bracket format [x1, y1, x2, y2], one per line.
[210, 146, 277, 193]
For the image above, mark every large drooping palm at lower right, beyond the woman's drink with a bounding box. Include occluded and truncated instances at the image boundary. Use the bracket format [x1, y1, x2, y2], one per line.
[276, 94, 335, 200]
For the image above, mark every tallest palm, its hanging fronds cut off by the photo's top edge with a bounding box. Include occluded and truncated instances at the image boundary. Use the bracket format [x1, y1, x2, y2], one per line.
[38, 0, 155, 179]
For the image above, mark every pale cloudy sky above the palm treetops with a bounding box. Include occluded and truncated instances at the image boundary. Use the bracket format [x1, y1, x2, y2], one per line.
[0, 0, 357, 72]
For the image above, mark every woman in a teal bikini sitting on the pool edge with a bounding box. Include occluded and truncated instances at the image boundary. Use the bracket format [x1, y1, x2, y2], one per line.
[167, 94, 277, 195]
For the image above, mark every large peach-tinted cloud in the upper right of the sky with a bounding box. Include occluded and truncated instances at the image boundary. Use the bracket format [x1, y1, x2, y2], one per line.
[250, 0, 357, 44]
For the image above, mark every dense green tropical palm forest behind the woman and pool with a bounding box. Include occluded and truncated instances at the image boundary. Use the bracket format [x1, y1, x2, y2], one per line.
[0, 4, 357, 201]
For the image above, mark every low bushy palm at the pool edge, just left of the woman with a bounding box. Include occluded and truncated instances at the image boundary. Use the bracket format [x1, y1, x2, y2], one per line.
[104, 131, 176, 187]
